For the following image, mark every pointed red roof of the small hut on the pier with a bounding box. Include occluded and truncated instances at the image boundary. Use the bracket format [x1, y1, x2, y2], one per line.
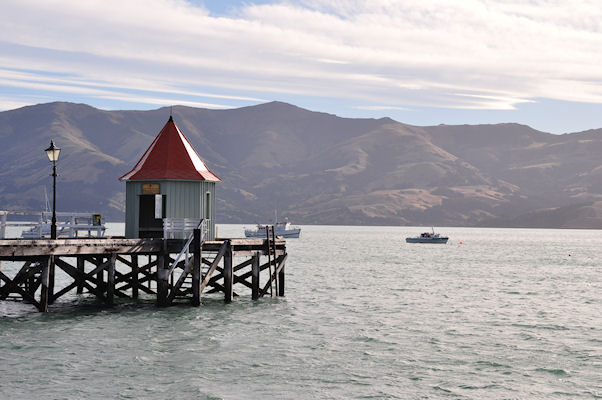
[119, 116, 221, 182]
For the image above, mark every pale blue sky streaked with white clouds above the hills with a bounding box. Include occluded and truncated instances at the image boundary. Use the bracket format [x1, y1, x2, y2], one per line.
[0, 0, 602, 133]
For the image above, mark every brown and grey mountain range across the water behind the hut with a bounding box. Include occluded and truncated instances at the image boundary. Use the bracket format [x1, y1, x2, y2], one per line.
[0, 102, 602, 229]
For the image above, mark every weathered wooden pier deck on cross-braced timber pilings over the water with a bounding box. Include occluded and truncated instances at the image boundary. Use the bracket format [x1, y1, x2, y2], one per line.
[0, 229, 287, 312]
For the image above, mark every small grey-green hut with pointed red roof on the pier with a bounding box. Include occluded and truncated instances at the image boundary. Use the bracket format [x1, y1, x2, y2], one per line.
[119, 116, 221, 240]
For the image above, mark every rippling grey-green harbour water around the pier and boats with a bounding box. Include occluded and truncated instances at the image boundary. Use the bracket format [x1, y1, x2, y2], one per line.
[0, 225, 602, 399]
